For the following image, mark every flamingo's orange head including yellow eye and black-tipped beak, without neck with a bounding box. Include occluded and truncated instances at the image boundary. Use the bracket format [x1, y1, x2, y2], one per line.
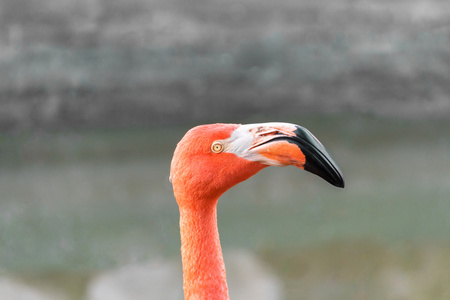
[170, 123, 344, 205]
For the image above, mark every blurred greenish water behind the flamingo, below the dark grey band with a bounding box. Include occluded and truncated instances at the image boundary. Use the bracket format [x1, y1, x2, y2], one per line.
[0, 115, 450, 299]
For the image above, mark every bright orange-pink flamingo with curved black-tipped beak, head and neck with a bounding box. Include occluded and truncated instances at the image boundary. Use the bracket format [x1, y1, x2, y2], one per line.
[170, 122, 344, 300]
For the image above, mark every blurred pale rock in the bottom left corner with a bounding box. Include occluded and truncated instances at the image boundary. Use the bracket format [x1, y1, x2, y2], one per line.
[0, 278, 68, 300]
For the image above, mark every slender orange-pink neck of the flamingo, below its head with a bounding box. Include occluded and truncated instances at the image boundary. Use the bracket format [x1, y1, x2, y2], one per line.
[180, 200, 230, 300]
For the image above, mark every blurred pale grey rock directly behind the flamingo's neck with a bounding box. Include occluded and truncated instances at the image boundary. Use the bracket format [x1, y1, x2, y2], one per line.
[86, 250, 282, 300]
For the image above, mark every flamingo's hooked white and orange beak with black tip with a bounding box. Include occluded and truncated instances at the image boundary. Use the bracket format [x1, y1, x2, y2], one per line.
[243, 123, 345, 188]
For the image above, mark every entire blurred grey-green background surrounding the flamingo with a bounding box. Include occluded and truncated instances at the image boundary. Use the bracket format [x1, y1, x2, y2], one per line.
[0, 0, 450, 300]
